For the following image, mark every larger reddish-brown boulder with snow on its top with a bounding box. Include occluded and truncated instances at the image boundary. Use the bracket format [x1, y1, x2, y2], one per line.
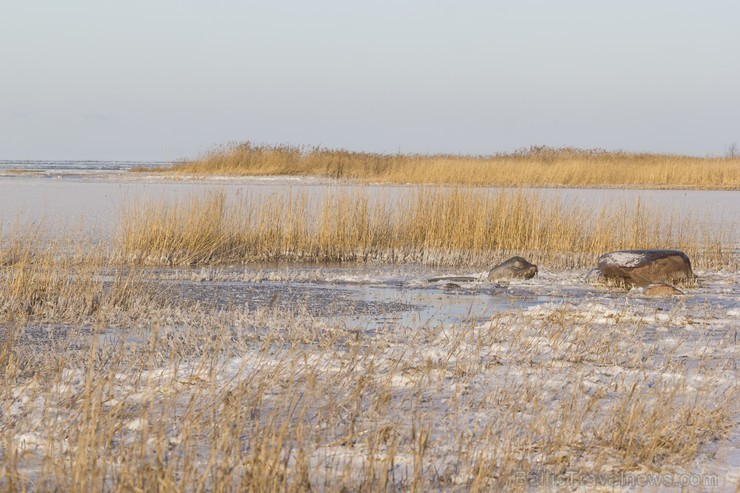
[597, 250, 694, 286]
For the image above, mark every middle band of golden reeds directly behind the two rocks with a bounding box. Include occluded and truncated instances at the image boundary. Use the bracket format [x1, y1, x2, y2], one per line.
[116, 188, 735, 267]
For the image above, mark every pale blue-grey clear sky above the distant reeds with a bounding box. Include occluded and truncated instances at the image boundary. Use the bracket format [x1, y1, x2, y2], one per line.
[0, 0, 740, 161]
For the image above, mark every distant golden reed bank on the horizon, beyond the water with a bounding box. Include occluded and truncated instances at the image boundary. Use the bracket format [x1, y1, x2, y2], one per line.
[153, 142, 740, 190]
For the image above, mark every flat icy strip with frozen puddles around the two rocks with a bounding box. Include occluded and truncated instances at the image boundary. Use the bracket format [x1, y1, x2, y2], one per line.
[130, 264, 740, 328]
